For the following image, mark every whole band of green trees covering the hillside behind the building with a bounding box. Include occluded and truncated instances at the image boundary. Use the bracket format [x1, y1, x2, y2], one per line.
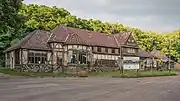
[0, 0, 180, 63]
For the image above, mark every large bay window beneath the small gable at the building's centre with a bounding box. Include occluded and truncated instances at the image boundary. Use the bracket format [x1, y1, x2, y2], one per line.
[68, 50, 88, 64]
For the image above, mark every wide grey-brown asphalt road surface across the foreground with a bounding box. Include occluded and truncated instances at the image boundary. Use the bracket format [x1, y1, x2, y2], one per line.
[0, 76, 180, 101]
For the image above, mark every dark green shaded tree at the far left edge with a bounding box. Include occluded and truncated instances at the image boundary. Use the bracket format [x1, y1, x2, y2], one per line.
[0, 0, 23, 65]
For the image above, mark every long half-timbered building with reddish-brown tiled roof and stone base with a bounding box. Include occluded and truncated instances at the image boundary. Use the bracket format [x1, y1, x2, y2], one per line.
[5, 26, 139, 71]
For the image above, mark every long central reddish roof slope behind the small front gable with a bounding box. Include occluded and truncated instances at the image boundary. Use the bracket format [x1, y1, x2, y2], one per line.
[49, 26, 129, 47]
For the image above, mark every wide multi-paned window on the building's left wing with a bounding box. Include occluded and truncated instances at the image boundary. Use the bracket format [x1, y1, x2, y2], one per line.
[28, 52, 47, 64]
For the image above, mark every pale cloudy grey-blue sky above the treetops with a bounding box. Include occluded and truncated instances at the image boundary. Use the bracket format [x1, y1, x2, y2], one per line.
[24, 0, 180, 33]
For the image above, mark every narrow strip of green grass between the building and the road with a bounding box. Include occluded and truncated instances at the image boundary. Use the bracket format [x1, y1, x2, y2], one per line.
[0, 68, 177, 78]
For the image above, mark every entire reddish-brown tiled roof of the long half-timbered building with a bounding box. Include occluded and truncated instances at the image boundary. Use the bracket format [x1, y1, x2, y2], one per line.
[6, 26, 135, 51]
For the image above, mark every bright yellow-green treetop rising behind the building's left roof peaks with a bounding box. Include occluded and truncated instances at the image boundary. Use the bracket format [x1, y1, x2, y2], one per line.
[19, 4, 71, 31]
